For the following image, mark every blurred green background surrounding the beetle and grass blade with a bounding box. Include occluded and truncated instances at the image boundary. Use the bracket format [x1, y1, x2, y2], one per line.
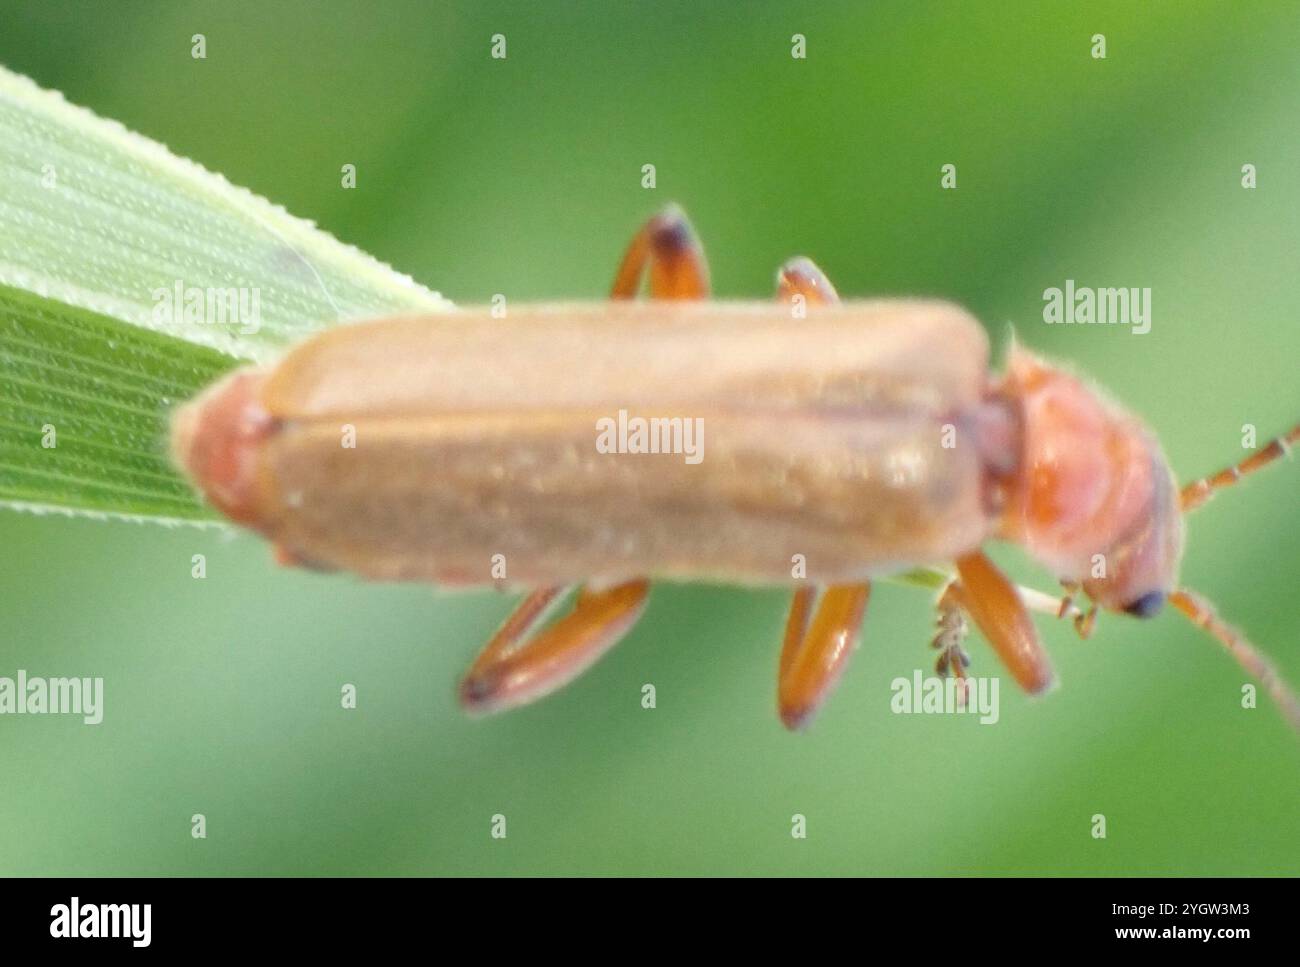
[0, 0, 1300, 875]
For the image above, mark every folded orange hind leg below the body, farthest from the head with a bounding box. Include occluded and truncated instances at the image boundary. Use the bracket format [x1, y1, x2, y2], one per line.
[460, 581, 650, 712]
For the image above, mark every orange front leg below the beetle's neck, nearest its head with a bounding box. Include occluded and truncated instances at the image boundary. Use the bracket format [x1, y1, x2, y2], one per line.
[945, 551, 1053, 694]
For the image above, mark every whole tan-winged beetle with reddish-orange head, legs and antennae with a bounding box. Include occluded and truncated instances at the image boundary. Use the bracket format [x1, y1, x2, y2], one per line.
[173, 208, 1300, 728]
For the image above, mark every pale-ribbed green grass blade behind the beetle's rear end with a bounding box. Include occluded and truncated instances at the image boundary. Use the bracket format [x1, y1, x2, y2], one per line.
[0, 69, 449, 520]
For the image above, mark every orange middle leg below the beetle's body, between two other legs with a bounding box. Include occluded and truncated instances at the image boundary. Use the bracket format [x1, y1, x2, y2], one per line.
[776, 582, 871, 729]
